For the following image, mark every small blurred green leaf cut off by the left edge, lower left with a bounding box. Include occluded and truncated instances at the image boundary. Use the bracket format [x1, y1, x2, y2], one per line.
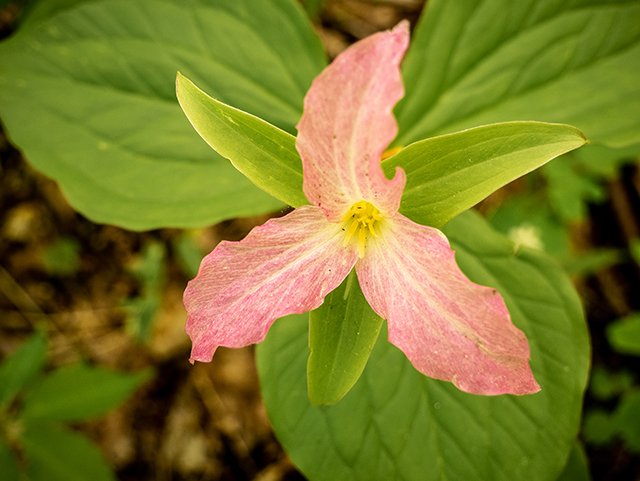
[0, 330, 47, 408]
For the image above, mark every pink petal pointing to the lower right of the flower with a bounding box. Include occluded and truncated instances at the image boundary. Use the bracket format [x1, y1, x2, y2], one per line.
[356, 214, 540, 395]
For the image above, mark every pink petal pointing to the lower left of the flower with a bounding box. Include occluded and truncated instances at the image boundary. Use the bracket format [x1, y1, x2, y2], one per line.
[184, 205, 358, 362]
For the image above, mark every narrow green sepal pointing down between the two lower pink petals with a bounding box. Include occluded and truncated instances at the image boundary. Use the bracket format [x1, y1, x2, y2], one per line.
[307, 270, 382, 405]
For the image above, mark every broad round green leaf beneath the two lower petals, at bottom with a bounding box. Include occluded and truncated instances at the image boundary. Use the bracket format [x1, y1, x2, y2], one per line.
[258, 212, 589, 481]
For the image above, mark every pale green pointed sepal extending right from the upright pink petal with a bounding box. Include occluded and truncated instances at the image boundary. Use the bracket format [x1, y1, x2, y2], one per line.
[382, 122, 586, 227]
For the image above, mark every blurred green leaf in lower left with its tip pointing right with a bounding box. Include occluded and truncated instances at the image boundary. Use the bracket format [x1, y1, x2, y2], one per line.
[21, 364, 152, 421]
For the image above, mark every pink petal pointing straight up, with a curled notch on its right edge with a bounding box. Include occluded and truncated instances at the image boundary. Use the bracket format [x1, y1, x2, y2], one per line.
[296, 21, 409, 222]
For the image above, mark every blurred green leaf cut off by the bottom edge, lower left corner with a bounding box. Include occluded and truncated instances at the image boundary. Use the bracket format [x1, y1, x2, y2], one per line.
[22, 422, 116, 481]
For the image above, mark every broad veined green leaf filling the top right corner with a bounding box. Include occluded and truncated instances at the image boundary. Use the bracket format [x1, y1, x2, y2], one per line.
[396, 0, 640, 147]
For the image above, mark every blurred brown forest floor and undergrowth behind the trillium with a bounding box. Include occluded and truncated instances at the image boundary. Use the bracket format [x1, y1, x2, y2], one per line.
[0, 0, 640, 481]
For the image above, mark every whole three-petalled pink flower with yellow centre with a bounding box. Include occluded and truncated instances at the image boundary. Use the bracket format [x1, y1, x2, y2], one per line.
[184, 22, 540, 394]
